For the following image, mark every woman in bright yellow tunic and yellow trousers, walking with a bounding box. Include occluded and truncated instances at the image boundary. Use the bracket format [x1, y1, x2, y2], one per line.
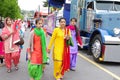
[48, 18, 69, 80]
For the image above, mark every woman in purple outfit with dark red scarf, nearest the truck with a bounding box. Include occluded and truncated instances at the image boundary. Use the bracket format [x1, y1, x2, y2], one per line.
[68, 18, 83, 71]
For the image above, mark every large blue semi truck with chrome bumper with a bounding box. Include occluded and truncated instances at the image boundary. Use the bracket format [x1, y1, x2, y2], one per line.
[70, 0, 120, 62]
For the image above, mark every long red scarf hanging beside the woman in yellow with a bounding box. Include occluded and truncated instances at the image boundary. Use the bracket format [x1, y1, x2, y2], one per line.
[61, 28, 70, 75]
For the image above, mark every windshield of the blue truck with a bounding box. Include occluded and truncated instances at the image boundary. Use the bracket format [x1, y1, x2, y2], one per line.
[96, 1, 120, 11]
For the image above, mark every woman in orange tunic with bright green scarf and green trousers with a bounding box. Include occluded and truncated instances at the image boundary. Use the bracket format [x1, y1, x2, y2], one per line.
[27, 19, 47, 80]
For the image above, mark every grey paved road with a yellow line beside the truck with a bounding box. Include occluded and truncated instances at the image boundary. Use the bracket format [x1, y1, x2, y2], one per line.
[0, 30, 120, 80]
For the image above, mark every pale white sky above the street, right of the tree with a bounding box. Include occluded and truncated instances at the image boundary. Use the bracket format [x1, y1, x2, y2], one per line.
[18, 0, 46, 11]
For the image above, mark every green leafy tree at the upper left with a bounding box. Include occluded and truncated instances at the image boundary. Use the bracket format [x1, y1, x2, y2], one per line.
[0, 0, 22, 19]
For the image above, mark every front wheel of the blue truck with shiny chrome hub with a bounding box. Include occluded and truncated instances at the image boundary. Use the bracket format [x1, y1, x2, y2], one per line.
[90, 35, 102, 62]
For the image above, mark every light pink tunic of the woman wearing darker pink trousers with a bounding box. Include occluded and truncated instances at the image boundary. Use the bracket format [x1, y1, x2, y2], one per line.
[1, 20, 19, 53]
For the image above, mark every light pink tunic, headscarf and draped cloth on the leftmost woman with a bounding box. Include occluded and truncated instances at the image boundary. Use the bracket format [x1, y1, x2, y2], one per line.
[1, 20, 20, 53]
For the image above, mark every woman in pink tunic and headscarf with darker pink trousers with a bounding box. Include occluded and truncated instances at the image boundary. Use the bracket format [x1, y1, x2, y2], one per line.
[2, 17, 20, 73]
